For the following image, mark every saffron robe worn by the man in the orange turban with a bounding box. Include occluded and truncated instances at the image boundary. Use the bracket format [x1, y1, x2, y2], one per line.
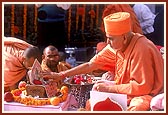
[90, 33, 164, 110]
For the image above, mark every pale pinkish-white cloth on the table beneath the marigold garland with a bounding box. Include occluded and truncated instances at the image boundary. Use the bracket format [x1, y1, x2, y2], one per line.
[2, 94, 78, 113]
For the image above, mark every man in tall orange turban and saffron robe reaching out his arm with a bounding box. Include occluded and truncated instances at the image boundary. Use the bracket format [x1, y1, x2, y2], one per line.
[44, 12, 164, 111]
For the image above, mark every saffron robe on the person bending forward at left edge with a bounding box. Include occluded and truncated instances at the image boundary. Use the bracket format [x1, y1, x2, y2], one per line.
[3, 37, 32, 89]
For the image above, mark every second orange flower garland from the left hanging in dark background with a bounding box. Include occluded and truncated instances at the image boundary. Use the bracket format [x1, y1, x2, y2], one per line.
[23, 5, 27, 41]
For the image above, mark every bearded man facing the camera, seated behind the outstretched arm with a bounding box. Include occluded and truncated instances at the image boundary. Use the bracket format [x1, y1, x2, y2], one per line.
[41, 45, 71, 87]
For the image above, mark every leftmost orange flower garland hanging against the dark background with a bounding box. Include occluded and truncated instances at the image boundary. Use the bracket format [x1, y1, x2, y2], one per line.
[11, 4, 15, 37]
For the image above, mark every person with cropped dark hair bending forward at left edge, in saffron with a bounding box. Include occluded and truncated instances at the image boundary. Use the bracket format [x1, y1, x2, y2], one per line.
[3, 37, 41, 92]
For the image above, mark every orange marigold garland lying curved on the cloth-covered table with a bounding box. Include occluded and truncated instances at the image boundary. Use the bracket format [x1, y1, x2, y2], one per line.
[11, 86, 69, 106]
